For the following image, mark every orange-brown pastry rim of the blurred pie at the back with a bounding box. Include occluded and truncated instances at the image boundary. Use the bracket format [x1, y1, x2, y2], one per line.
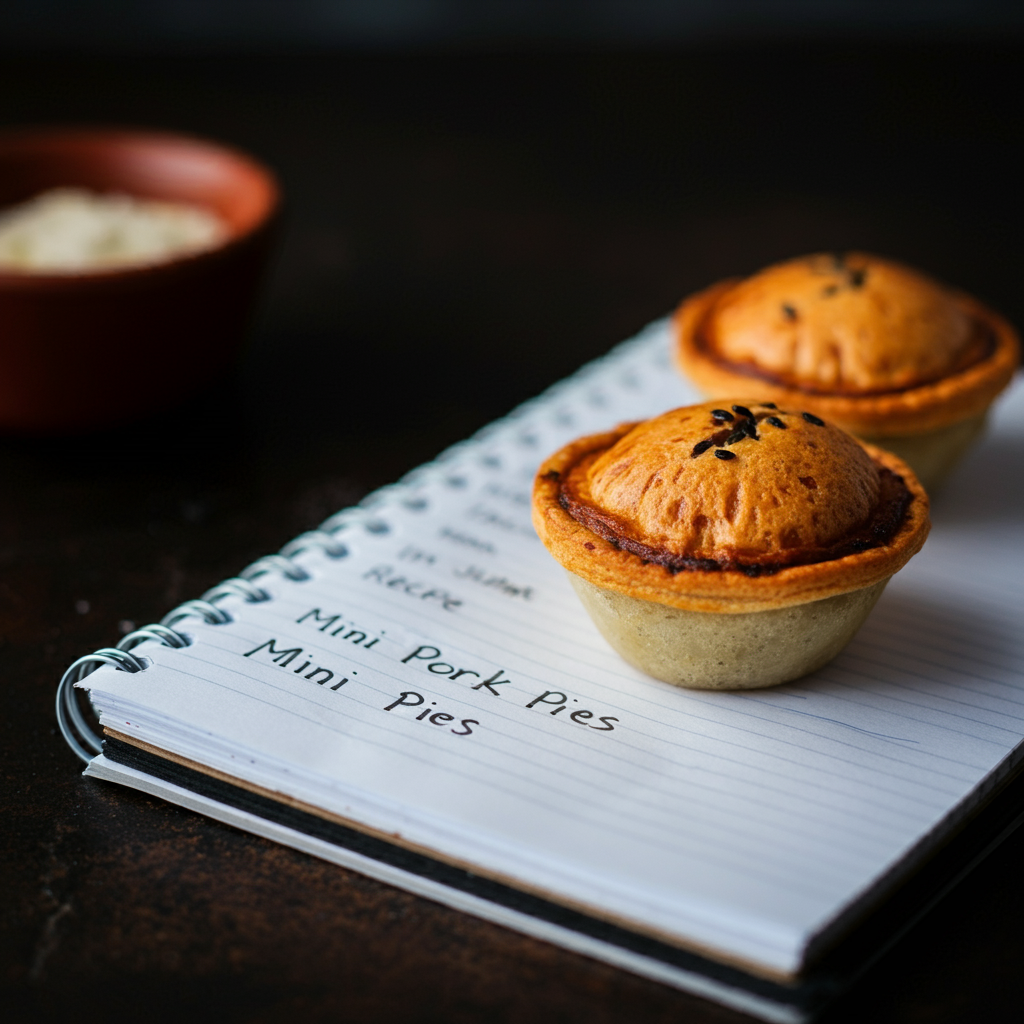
[673, 279, 1021, 437]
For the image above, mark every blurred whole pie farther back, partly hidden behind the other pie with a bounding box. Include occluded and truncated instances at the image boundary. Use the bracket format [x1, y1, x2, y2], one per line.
[675, 253, 1020, 486]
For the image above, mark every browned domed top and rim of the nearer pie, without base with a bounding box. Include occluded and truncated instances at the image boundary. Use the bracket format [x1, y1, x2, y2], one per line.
[534, 400, 928, 611]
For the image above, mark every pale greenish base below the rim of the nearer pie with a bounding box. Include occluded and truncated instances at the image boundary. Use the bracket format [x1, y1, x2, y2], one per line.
[568, 572, 889, 690]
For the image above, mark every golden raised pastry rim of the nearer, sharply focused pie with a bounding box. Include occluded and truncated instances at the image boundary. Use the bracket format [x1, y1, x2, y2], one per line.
[532, 423, 931, 613]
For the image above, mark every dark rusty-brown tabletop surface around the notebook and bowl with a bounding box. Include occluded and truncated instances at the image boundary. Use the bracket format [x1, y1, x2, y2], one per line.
[0, 42, 1024, 1024]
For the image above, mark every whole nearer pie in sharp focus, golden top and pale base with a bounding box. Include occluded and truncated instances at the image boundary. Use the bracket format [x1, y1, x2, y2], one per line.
[532, 400, 929, 689]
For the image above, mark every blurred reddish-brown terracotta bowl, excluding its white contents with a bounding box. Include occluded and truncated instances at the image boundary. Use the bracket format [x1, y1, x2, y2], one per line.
[0, 130, 279, 433]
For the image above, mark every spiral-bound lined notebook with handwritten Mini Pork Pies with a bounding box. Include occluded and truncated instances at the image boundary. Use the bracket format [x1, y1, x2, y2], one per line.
[57, 323, 1024, 1021]
